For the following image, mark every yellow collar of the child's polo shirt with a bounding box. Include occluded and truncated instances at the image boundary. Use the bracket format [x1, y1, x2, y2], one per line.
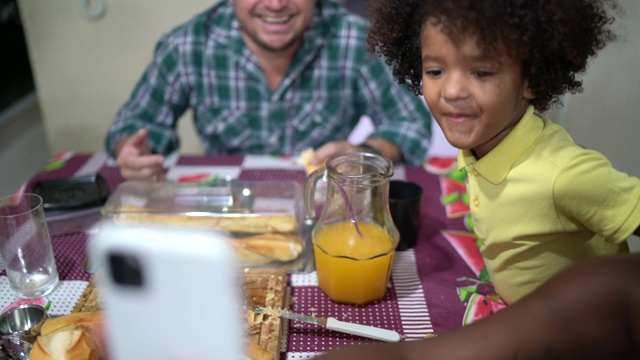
[458, 105, 544, 184]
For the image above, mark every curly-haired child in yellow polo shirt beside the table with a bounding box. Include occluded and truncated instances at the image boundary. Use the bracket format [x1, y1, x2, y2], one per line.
[367, 0, 640, 303]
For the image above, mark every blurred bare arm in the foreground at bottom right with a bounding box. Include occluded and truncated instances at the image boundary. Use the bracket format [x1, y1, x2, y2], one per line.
[320, 253, 640, 360]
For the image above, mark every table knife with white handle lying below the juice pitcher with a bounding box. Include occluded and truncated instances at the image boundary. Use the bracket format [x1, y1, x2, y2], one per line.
[253, 307, 400, 342]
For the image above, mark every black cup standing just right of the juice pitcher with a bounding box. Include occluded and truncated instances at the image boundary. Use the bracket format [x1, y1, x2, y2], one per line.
[389, 180, 422, 251]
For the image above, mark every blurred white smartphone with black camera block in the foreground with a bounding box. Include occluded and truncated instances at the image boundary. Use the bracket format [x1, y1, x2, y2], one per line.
[90, 223, 243, 360]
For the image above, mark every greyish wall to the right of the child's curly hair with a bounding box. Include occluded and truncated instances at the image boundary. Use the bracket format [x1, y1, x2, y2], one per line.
[557, 0, 640, 176]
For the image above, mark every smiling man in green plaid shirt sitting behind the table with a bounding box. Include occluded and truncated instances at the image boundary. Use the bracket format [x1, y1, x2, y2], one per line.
[105, 0, 431, 179]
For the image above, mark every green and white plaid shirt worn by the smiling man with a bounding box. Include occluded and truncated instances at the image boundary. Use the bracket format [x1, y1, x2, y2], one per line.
[105, 0, 431, 164]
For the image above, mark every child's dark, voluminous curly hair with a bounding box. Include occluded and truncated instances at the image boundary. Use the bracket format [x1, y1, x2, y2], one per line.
[367, 0, 618, 112]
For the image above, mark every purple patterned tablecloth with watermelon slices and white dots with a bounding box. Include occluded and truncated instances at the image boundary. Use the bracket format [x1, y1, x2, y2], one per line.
[0, 153, 485, 359]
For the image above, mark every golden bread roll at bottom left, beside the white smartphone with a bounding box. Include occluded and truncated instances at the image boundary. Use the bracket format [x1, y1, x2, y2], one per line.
[29, 311, 108, 360]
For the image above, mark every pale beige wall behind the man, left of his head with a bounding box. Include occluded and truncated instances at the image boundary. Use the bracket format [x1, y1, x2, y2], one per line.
[18, 0, 216, 153]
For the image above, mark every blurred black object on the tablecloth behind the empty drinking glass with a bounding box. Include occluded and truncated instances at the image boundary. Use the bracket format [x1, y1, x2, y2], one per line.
[32, 174, 109, 211]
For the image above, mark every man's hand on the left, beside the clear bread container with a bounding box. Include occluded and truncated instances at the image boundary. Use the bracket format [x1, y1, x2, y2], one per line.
[115, 129, 164, 181]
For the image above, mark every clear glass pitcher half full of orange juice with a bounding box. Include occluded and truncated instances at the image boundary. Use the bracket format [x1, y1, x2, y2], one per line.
[305, 153, 399, 305]
